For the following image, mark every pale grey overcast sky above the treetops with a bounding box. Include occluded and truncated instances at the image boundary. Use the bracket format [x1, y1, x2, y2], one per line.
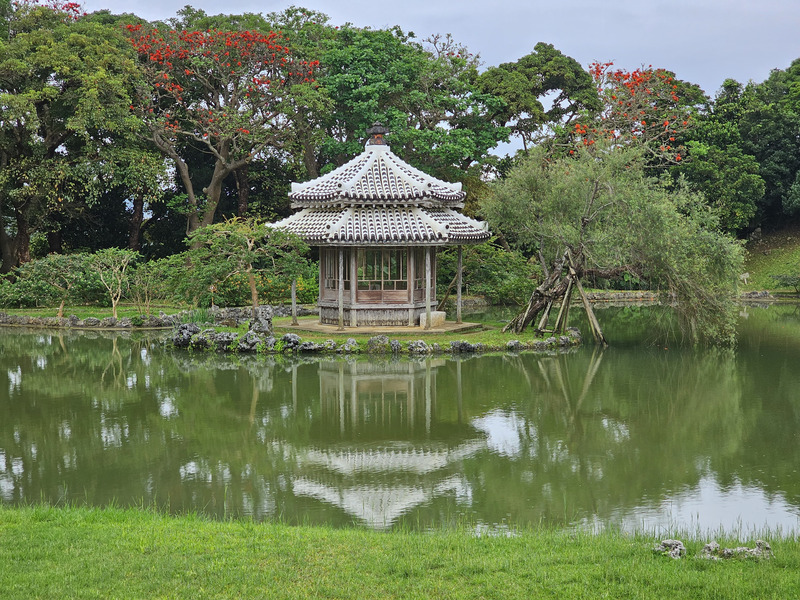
[82, 0, 800, 96]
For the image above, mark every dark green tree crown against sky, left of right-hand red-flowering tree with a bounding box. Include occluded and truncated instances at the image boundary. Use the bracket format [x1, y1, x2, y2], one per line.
[478, 42, 601, 151]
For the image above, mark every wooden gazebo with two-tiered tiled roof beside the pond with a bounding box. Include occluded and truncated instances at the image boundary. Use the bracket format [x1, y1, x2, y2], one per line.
[273, 123, 490, 329]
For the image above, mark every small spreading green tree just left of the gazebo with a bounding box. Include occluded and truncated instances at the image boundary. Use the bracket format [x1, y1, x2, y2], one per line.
[188, 218, 308, 318]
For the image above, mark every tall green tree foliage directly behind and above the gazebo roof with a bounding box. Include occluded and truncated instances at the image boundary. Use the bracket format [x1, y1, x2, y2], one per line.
[290, 22, 508, 183]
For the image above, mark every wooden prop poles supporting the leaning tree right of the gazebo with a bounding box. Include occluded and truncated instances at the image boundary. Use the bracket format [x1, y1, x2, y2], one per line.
[503, 248, 608, 346]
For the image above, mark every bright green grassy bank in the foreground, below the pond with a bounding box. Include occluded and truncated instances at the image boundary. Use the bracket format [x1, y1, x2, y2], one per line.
[0, 507, 800, 599]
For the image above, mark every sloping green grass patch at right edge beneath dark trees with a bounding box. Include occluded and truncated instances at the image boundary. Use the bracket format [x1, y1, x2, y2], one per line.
[740, 226, 800, 294]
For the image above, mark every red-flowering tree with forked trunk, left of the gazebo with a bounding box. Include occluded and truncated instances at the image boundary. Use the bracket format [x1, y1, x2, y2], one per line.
[127, 25, 318, 233]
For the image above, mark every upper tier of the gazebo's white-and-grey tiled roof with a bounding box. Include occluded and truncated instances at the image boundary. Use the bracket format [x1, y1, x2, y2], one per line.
[289, 144, 466, 208]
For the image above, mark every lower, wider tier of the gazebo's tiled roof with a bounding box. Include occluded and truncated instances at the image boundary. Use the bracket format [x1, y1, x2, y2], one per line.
[273, 206, 490, 246]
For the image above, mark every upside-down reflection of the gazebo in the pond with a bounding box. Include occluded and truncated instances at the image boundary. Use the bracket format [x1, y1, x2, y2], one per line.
[292, 359, 487, 528]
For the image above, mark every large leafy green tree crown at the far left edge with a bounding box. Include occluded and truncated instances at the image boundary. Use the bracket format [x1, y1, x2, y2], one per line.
[0, 0, 142, 272]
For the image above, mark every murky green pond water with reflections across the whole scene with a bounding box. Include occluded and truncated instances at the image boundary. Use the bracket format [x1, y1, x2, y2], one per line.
[0, 305, 800, 533]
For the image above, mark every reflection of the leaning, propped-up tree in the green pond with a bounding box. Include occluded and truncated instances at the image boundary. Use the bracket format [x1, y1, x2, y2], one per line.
[440, 349, 746, 522]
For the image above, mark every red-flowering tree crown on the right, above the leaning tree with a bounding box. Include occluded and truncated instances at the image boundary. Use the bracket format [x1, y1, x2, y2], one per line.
[571, 62, 703, 164]
